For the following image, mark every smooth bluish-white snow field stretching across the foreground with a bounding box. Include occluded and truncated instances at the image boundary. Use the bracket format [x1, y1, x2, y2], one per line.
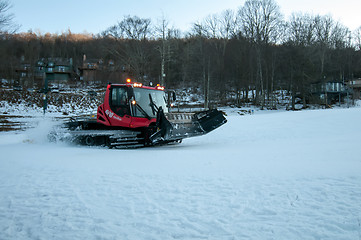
[0, 108, 361, 240]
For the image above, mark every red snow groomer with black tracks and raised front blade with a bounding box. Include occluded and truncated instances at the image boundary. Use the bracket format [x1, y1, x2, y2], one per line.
[55, 81, 227, 148]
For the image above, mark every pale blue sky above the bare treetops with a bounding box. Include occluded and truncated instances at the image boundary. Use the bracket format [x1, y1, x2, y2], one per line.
[10, 0, 361, 34]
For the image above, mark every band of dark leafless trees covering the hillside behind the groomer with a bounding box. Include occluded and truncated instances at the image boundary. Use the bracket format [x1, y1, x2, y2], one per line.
[0, 0, 361, 107]
